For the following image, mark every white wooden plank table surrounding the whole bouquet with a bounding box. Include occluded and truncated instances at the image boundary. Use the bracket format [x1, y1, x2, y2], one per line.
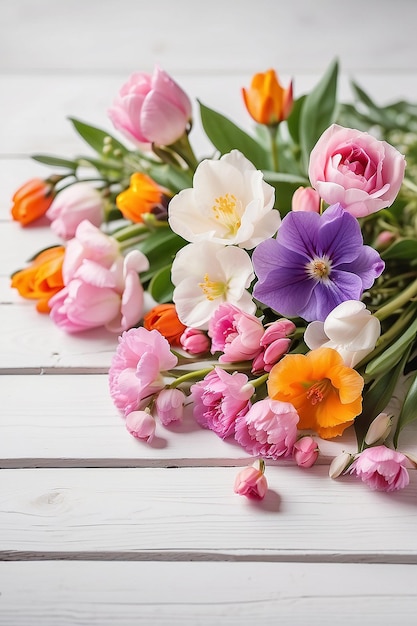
[0, 0, 417, 626]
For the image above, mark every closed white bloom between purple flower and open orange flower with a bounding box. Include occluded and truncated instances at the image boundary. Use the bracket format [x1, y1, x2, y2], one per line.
[304, 300, 381, 367]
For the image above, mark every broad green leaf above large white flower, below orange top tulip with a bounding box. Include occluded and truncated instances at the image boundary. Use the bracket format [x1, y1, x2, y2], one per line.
[199, 102, 270, 169]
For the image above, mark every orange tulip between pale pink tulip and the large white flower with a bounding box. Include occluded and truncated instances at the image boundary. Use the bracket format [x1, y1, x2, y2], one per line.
[116, 172, 163, 222]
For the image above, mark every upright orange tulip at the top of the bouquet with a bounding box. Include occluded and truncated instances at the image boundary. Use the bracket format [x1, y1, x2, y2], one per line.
[242, 70, 293, 126]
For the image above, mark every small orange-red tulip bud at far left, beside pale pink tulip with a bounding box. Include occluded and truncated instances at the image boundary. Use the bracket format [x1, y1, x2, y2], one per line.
[11, 178, 53, 226]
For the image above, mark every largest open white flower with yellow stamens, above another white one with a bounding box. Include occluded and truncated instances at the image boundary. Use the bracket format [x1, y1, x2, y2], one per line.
[168, 150, 281, 250]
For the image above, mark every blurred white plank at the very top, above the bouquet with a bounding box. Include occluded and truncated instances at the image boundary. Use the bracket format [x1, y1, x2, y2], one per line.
[0, 0, 417, 73]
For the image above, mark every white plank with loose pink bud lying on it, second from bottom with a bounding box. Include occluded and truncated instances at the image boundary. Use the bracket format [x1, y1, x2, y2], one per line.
[0, 466, 417, 563]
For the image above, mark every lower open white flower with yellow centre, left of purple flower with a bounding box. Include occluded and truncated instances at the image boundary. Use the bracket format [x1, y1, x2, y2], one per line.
[171, 241, 256, 330]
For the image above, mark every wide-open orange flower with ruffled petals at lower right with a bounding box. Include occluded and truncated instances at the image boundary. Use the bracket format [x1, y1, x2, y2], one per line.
[268, 348, 364, 439]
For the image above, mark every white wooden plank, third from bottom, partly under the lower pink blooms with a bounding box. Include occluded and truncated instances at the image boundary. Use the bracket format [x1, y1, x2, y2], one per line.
[0, 375, 362, 466]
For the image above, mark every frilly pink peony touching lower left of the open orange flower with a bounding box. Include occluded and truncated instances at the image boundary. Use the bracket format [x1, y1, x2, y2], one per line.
[235, 398, 299, 460]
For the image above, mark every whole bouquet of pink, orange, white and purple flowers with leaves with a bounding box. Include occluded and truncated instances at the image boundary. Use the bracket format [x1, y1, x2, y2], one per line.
[12, 60, 417, 498]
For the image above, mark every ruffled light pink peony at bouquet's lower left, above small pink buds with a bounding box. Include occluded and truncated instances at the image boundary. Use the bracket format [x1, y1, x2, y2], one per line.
[109, 327, 178, 416]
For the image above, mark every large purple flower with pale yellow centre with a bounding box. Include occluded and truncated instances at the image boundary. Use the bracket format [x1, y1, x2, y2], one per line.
[252, 204, 384, 322]
